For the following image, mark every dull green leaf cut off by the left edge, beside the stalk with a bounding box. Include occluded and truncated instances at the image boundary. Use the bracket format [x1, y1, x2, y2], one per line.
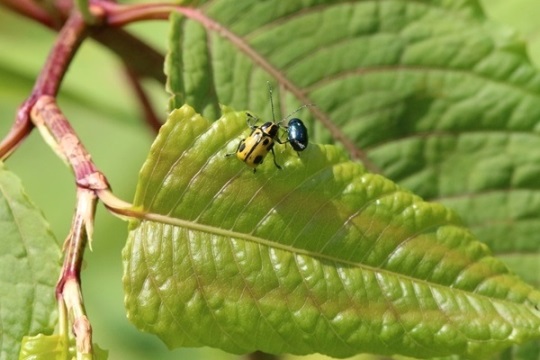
[0, 164, 60, 360]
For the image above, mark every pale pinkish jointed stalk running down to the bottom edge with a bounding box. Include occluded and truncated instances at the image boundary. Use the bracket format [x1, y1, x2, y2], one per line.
[31, 95, 110, 359]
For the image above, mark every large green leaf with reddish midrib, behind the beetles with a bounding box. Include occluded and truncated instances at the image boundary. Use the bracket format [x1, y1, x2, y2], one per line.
[167, 0, 540, 296]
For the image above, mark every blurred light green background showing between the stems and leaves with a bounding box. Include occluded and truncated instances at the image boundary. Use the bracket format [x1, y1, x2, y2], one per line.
[0, 0, 540, 360]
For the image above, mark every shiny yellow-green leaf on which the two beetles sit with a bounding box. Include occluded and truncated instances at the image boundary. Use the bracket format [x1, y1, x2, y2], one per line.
[124, 105, 540, 358]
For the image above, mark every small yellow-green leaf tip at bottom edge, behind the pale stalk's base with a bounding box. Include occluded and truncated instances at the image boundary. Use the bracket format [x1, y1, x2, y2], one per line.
[19, 334, 109, 360]
